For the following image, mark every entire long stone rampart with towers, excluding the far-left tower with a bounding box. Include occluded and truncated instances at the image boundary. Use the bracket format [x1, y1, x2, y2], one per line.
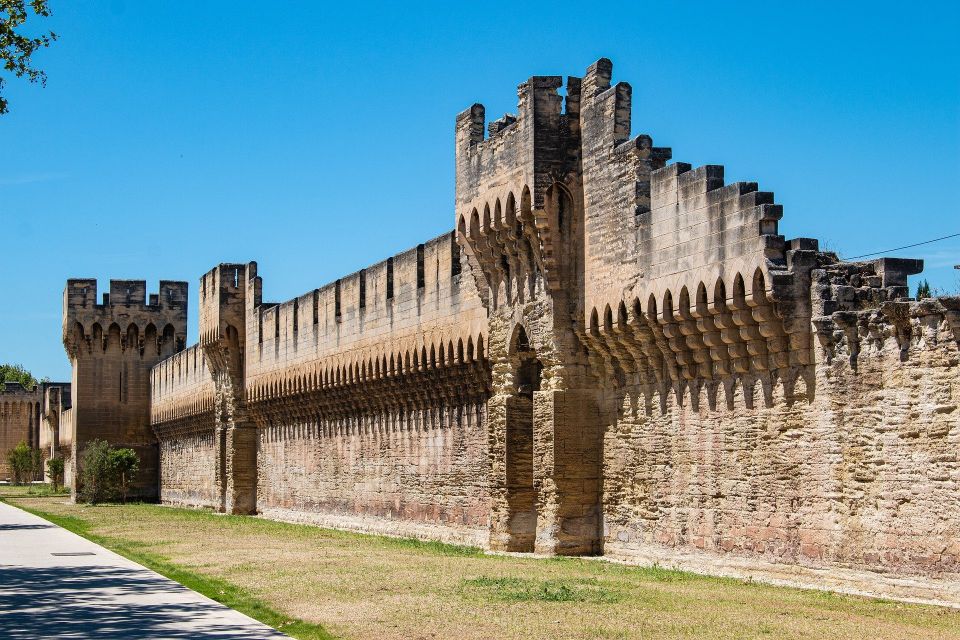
[133, 59, 960, 604]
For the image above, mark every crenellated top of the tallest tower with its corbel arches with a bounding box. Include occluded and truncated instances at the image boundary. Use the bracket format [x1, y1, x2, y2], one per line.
[456, 76, 580, 298]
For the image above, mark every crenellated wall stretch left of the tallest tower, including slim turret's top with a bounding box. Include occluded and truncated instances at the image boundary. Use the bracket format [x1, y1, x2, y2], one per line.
[151, 234, 489, 542]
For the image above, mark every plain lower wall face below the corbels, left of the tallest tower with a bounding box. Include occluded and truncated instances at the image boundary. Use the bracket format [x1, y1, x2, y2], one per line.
[257, 404, 489, 545]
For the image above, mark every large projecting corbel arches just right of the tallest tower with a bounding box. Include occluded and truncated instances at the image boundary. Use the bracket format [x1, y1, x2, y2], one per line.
[583, 267, 812, 384]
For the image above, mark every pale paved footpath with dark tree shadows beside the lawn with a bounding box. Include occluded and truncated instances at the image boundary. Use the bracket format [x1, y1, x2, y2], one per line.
[0, 502, 287, 640]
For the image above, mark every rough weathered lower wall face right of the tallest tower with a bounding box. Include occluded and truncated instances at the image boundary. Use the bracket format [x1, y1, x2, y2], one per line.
[603, 300, 960, 598]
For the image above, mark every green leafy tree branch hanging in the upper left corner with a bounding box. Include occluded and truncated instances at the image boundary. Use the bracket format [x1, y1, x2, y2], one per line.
[0, 0, 57, 115]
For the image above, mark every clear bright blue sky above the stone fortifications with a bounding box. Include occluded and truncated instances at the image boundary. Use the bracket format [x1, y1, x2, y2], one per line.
[0, 0, 960, 379]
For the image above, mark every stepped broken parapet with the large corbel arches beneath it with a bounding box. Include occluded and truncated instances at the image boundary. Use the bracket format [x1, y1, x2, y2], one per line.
[582, 163, 817, 392]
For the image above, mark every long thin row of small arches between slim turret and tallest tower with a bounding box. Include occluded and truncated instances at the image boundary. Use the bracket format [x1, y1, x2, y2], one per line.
[247, 332, 487, 402]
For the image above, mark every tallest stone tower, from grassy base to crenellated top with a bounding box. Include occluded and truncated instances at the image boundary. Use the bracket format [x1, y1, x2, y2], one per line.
[456, 69, 608, 555]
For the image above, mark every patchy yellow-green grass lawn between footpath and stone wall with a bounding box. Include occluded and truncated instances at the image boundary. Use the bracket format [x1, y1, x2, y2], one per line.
[8, 497, 960, 640]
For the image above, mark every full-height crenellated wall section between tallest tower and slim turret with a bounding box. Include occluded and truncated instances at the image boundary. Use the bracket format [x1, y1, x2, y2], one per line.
[246, 234, 487, 541]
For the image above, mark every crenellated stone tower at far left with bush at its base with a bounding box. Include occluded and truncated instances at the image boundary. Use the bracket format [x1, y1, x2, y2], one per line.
[63, 279, 187, 499]
